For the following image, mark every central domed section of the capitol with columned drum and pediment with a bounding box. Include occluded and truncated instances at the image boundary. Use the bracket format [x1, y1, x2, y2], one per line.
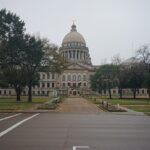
[59, 24, 94, 95]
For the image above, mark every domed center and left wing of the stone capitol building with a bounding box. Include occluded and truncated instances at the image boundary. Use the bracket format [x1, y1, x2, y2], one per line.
[0, 24, 96, 96]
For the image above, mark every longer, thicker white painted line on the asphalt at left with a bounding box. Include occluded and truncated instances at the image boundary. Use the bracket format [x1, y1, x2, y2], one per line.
[0, 113, 40, 138]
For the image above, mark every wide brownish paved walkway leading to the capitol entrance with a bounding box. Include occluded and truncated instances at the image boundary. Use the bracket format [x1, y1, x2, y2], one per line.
[58, 97, 102, 113]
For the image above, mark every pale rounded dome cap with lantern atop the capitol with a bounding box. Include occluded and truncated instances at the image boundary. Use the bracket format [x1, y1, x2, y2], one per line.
[62, 24, 85, 44]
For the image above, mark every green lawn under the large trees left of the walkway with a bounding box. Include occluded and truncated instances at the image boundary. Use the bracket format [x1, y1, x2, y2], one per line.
[0, 96, 51, 112]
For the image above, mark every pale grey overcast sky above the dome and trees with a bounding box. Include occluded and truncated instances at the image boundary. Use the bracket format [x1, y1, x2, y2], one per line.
[0, 0, 150, 65]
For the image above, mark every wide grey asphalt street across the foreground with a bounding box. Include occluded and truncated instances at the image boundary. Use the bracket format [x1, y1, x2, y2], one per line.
[0, 112, 150, 150]
